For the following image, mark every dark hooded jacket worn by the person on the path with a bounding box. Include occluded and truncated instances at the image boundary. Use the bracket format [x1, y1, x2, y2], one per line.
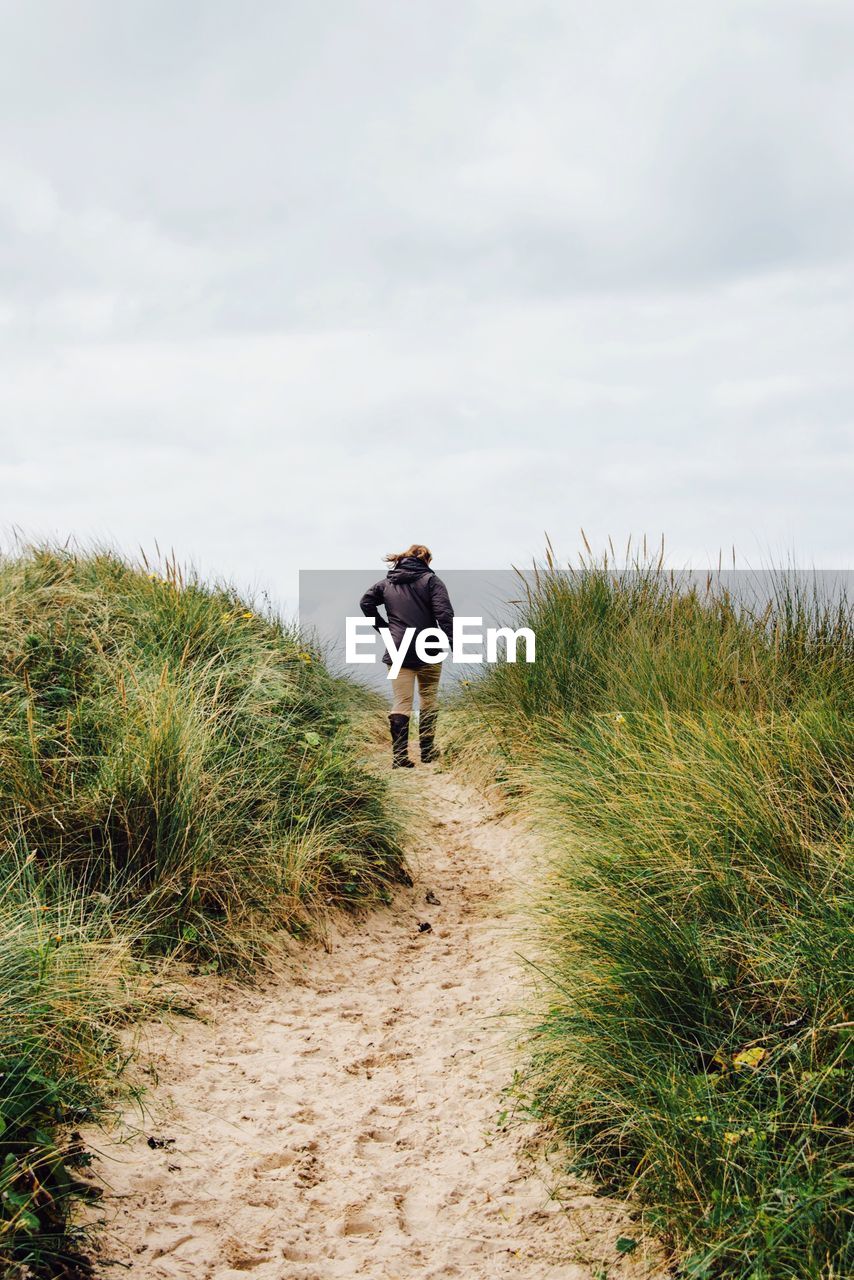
[359, 556, 453, 671]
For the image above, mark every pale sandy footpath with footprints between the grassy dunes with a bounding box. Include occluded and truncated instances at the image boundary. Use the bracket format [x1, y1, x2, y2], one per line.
[90, 769, 661, 1280]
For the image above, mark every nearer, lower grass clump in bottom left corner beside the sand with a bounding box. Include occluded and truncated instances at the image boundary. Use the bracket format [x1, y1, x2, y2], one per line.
[0, 856, 147, 1277]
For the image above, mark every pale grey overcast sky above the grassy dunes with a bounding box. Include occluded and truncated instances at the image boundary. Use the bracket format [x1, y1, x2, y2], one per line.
[0, 0, 854, 599]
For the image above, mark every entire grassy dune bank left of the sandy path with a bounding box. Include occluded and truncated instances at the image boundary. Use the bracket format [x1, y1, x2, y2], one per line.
[0, 548, 406, 1275]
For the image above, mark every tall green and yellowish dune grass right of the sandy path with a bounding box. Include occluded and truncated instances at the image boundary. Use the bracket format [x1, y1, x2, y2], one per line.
[457, 563, 854, 1280]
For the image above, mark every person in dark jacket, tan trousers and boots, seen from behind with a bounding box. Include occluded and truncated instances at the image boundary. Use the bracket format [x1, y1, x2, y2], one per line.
[359, 543, 453, 769]
